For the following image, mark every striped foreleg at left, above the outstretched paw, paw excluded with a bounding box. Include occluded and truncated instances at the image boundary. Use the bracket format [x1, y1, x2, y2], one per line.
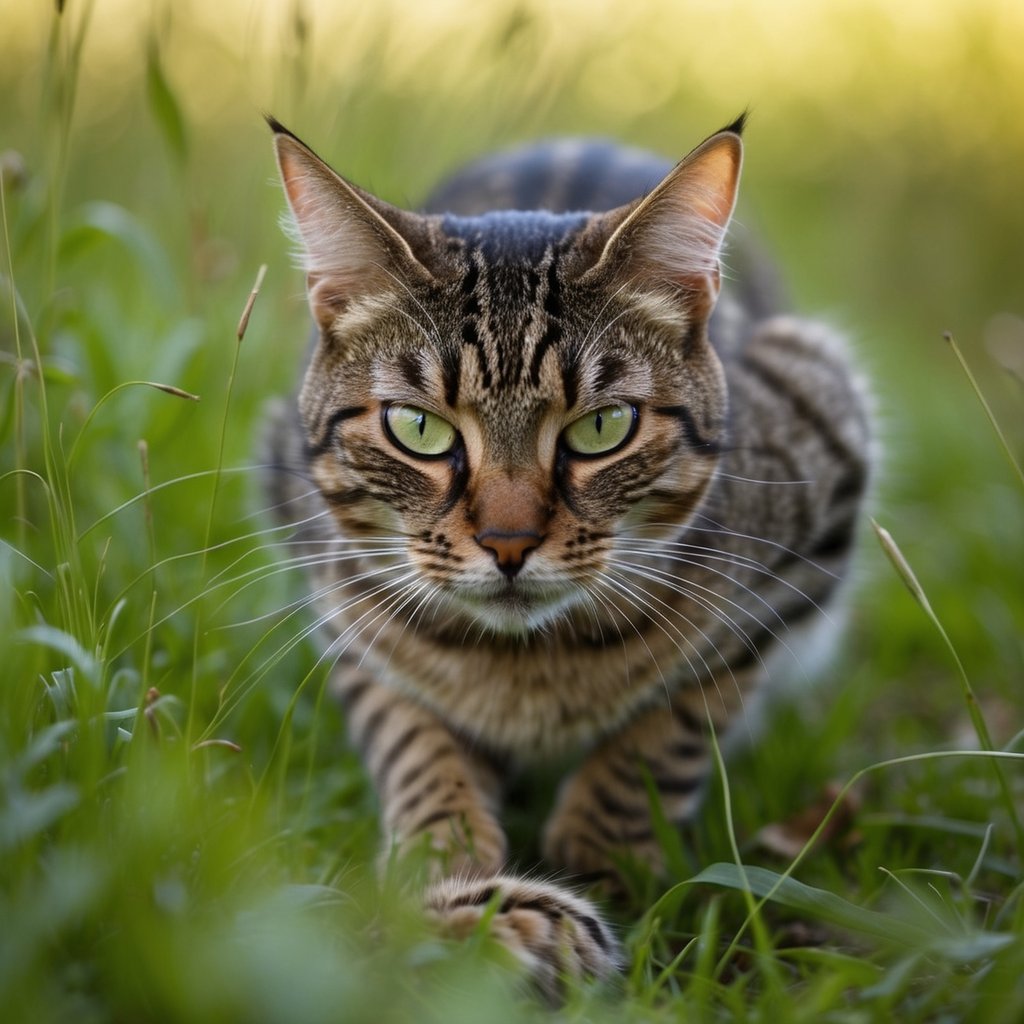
[335, 669, 506, 878]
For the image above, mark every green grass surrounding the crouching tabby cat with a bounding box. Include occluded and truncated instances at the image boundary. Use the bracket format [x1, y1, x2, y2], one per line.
[0, 0, 1024, 1022]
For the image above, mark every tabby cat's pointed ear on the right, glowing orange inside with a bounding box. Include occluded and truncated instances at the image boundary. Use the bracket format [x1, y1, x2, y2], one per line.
[593, 119, 742, 312]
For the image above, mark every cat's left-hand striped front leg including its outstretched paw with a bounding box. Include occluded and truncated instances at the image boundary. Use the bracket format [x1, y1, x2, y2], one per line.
[336, 670, 622, 1004]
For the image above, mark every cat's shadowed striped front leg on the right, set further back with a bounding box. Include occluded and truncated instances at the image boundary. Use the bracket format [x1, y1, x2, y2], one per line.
[544, 689, 728, 885]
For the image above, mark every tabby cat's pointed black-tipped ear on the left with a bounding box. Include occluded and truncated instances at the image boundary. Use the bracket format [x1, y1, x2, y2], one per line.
[267, 118, 430, 331]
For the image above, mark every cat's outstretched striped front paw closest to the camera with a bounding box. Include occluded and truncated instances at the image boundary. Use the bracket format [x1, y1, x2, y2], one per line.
[425, 874, 623, 1002]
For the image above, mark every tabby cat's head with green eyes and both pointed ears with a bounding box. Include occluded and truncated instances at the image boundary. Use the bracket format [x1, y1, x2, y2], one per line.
[271, 122, 741, 633]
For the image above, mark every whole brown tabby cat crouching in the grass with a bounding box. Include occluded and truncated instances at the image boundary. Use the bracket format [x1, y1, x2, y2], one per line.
[271, 114, 867, 993]
